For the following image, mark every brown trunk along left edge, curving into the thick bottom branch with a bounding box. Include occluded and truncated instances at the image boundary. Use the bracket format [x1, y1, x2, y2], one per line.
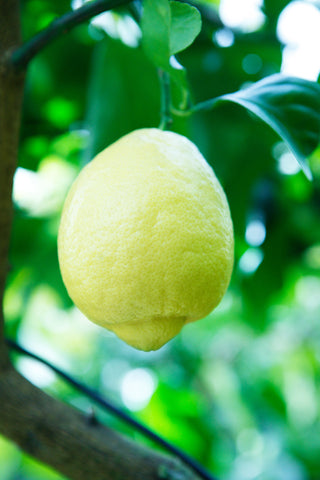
[0, 0, 199, 480]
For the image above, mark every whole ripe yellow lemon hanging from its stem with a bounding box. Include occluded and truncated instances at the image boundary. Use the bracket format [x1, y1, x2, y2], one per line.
[58, 128, 233, 351]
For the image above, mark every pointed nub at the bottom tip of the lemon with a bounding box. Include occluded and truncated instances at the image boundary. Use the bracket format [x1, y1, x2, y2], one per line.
[107, 316, 187, 352]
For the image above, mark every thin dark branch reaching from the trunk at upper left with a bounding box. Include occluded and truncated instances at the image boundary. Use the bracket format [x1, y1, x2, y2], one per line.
[10, 0, 131, 69]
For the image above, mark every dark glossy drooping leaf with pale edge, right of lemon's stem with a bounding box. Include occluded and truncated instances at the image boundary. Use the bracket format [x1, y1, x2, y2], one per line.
[217, 74, 320, 179]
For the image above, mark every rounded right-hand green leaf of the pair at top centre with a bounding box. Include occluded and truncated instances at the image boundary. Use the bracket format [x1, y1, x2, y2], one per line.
[170, 1, 201, 55]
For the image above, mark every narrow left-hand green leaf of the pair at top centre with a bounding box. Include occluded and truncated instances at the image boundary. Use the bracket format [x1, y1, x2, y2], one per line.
[141, 0, 171, 70]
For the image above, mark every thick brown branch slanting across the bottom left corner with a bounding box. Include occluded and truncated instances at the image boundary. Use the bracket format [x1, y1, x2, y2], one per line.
[0, 368, 199, 480]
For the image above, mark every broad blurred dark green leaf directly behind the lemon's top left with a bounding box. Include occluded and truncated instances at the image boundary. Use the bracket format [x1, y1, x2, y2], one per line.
[85, 38, 160, 161]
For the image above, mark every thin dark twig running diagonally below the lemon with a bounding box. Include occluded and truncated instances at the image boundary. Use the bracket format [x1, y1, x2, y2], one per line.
[6, 339, 216, 480]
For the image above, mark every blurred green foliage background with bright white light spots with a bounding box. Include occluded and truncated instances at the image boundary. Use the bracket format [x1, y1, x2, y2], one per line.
[0, 0, 320, 480]
